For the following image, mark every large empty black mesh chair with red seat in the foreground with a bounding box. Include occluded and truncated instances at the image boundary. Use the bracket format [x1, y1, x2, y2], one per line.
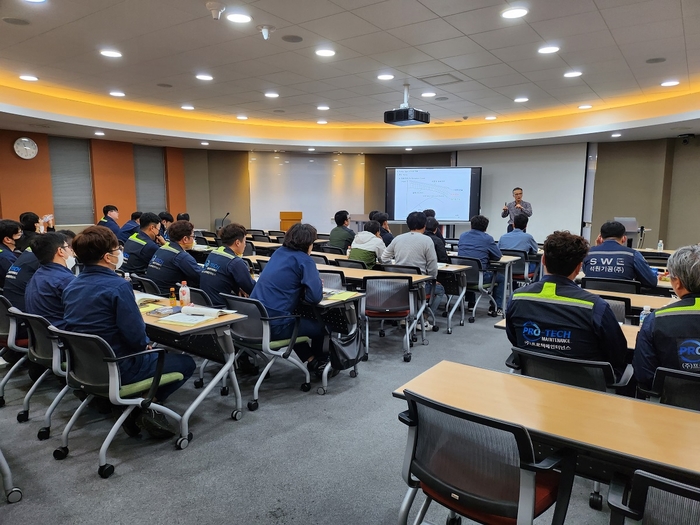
[399, 390, 576, 525]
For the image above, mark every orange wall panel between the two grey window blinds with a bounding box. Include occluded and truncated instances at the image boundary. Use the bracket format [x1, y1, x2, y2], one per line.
[90, 140, 136, 221]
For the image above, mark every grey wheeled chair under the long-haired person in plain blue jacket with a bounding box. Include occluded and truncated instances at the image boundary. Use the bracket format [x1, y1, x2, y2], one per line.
[221, 293, 311, 411]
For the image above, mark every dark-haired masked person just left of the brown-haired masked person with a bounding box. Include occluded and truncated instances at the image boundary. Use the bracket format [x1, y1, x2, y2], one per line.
[25, 232, 75, 330]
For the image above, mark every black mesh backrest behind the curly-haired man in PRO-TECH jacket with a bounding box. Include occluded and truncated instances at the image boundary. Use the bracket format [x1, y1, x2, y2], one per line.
[512, 347, 615, 392]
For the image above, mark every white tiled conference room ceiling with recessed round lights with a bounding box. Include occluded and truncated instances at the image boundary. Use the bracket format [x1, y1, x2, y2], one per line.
[0, 0, 700, 150]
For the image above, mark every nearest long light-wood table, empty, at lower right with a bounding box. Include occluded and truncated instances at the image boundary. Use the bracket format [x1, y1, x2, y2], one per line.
[393, 361, 700, 482]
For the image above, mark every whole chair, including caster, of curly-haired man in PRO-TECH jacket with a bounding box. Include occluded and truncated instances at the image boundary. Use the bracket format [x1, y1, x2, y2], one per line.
[506, 347, 634, 510]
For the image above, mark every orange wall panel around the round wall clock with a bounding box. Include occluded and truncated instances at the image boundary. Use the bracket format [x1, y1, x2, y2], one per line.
[0, 130, 53, 221]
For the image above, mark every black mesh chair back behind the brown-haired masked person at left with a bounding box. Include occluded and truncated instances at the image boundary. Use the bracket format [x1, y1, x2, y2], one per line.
[49, 326, 115, 397]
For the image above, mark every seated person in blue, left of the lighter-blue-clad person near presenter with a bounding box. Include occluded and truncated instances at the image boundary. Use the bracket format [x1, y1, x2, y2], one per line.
[457, 215, 505, 316]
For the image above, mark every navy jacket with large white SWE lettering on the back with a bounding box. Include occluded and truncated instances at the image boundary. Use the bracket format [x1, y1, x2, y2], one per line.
[583, 240, 657, 288]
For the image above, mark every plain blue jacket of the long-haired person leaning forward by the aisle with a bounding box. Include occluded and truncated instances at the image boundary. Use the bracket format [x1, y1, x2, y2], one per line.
[250, 246, 323, 326]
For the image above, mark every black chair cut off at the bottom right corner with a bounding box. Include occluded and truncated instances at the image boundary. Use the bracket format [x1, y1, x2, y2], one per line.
[608, 470, 700, 525]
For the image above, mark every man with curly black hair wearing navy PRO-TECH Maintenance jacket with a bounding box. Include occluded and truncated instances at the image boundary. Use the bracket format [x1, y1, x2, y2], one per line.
[506, 231, 627, 378]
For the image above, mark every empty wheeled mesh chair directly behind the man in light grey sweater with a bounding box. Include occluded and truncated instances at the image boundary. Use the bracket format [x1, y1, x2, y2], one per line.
[360, 276, 415, 363]
